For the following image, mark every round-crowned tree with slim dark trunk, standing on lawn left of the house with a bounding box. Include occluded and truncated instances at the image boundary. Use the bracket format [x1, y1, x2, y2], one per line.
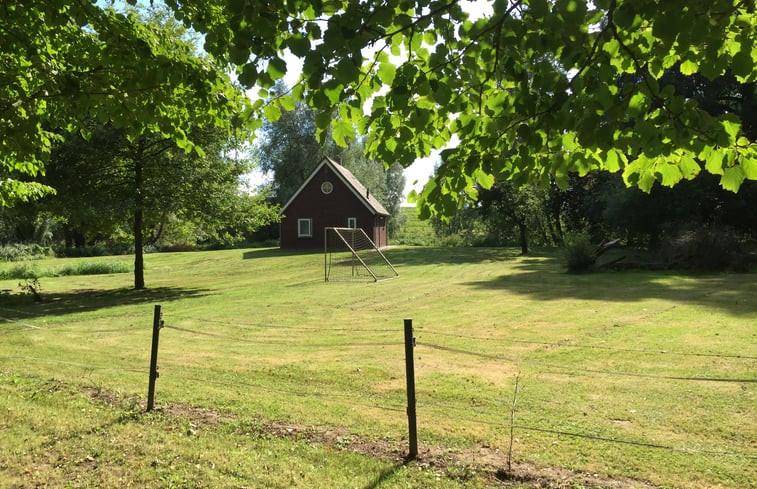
[40, 122, 277, 289]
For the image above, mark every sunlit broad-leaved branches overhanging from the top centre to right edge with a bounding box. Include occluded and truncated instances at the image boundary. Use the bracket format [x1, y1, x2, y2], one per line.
[168, 0, 757, 214]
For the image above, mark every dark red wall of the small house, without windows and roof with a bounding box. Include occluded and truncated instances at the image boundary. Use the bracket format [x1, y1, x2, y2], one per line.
[280, 165, 386, 250]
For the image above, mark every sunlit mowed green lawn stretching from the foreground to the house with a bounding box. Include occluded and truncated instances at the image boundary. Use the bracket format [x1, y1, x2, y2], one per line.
[0, 248, 757, 488]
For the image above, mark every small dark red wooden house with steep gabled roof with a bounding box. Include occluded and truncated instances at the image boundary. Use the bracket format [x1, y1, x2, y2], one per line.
[280, 157, 389, 249]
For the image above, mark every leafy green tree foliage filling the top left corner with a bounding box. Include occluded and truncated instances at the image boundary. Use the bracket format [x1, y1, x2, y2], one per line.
[0, 0, 254, 206]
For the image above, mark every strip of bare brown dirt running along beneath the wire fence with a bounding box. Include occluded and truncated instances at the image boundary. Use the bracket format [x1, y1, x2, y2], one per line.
[81, 387, 657, 489]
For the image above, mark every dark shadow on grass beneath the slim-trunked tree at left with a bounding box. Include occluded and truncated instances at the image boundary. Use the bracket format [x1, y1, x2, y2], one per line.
[0, 287, 210, 320]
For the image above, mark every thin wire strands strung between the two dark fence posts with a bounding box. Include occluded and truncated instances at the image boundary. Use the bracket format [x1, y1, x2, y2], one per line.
[0, 308, 757, 466]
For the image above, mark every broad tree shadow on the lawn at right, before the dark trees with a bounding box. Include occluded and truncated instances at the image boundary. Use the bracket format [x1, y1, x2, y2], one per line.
[465, 258, 757, 316]
